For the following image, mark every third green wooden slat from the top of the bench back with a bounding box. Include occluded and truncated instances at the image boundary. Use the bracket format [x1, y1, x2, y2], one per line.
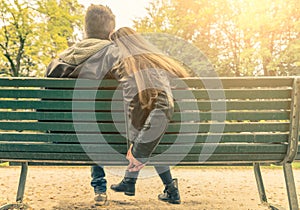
[0, 100, 290, 111]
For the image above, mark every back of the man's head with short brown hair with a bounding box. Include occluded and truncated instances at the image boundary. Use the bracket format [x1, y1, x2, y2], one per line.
[85, 4, 116, 39]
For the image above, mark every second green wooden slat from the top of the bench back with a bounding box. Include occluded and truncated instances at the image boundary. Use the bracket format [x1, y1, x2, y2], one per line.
[0, 89, 291, 100]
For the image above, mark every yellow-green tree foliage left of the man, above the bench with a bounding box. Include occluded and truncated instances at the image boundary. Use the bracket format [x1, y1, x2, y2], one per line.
[0, 0, 84, 77]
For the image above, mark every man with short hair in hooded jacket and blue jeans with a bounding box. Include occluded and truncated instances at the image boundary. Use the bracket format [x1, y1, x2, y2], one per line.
[46, 5, 118, 205]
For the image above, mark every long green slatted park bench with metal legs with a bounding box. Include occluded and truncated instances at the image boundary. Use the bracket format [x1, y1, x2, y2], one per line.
[0, 77, 300, 210]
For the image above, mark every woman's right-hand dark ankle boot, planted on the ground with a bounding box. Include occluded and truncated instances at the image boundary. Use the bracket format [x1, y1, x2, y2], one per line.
[158, 179, 181, 204]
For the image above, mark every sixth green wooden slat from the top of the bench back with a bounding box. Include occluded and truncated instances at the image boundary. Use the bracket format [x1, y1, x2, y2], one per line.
[0, 133, 288, 144]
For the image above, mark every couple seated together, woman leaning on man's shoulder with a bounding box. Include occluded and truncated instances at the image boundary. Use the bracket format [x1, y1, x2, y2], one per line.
[46, 5, 188, 205]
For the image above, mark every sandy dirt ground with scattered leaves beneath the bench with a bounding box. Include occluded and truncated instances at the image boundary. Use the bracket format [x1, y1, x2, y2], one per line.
[0, 166, 300, 210]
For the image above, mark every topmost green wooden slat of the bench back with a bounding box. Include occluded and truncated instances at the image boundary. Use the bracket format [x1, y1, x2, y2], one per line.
[0, 77, 294, 88]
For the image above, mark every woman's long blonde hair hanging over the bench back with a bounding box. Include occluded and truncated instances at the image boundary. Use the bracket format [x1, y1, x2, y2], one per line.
[111, 27, 189, 109]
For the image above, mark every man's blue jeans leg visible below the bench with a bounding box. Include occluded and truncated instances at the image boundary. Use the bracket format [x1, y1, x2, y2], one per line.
[91, 165, 107, 193]
